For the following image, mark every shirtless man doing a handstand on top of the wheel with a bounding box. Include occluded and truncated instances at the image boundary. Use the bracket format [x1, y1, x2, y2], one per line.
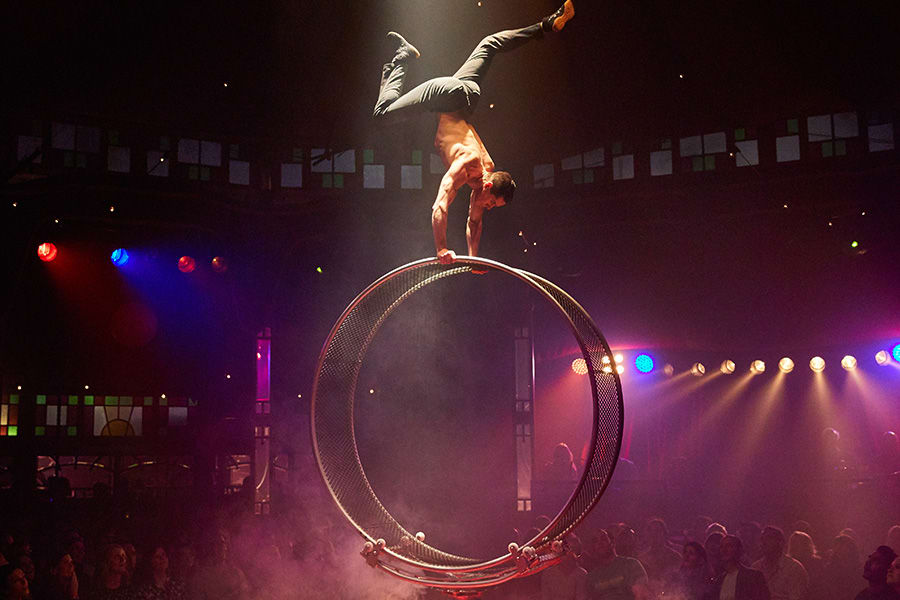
[374, 0, 575, 264]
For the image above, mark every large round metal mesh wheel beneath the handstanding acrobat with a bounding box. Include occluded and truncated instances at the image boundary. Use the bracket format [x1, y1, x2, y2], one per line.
[311, 256, 623, 596]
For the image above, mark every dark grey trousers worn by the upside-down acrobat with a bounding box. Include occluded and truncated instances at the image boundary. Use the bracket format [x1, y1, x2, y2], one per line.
[373, 23, 543, 121]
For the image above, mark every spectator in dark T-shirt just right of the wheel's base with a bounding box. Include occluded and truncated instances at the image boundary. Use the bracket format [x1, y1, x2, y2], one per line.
[587, 529, 649, 600]
